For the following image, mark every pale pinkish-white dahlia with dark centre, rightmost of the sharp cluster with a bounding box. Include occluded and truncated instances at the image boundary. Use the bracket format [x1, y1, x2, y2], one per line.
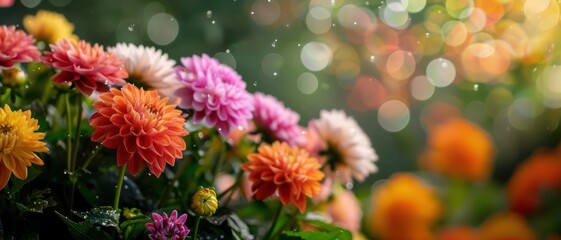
[309, 110, 378, 183]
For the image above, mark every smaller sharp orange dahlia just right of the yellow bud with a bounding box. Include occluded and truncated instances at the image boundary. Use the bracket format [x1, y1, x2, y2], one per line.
[241, 142, 324, 213]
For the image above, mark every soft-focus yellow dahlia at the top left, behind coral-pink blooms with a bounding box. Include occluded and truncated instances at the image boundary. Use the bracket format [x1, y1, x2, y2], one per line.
[23, 10, 78, 43]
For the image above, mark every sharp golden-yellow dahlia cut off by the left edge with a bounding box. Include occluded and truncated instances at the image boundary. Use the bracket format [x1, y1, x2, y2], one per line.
[0, 105, 49, 189]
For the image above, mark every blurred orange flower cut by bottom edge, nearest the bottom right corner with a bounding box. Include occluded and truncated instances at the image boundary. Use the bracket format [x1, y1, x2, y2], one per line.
[479, 212, 536, 240]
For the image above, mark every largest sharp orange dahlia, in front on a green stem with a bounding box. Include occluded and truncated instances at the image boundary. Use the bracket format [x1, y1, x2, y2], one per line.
[90, 84, 189, 177]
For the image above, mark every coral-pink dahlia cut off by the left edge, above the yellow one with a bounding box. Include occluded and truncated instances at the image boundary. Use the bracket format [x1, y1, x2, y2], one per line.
[0, 25, 41, 69]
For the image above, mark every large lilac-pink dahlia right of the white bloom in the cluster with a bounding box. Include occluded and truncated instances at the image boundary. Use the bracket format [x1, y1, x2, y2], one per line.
[175, 54, 253, 136]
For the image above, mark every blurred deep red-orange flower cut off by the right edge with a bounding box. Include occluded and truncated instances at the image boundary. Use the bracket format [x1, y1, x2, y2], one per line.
[507, 149, 561, 214]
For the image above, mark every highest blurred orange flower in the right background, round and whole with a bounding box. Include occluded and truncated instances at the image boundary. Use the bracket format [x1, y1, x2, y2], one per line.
[420, 118, 494, 181]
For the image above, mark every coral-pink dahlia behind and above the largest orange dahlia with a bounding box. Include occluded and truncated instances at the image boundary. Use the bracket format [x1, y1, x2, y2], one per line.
[43, 39, 128, 96]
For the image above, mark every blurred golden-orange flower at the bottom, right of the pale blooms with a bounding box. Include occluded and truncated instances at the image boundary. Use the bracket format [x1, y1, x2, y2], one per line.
[367, 173, 441, 240]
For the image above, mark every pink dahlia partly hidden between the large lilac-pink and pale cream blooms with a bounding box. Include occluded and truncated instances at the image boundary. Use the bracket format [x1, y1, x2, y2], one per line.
[253, 93, 306, 146]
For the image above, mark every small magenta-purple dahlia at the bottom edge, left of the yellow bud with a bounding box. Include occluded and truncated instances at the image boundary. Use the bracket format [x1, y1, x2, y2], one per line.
[145, 210, 190, 240]
